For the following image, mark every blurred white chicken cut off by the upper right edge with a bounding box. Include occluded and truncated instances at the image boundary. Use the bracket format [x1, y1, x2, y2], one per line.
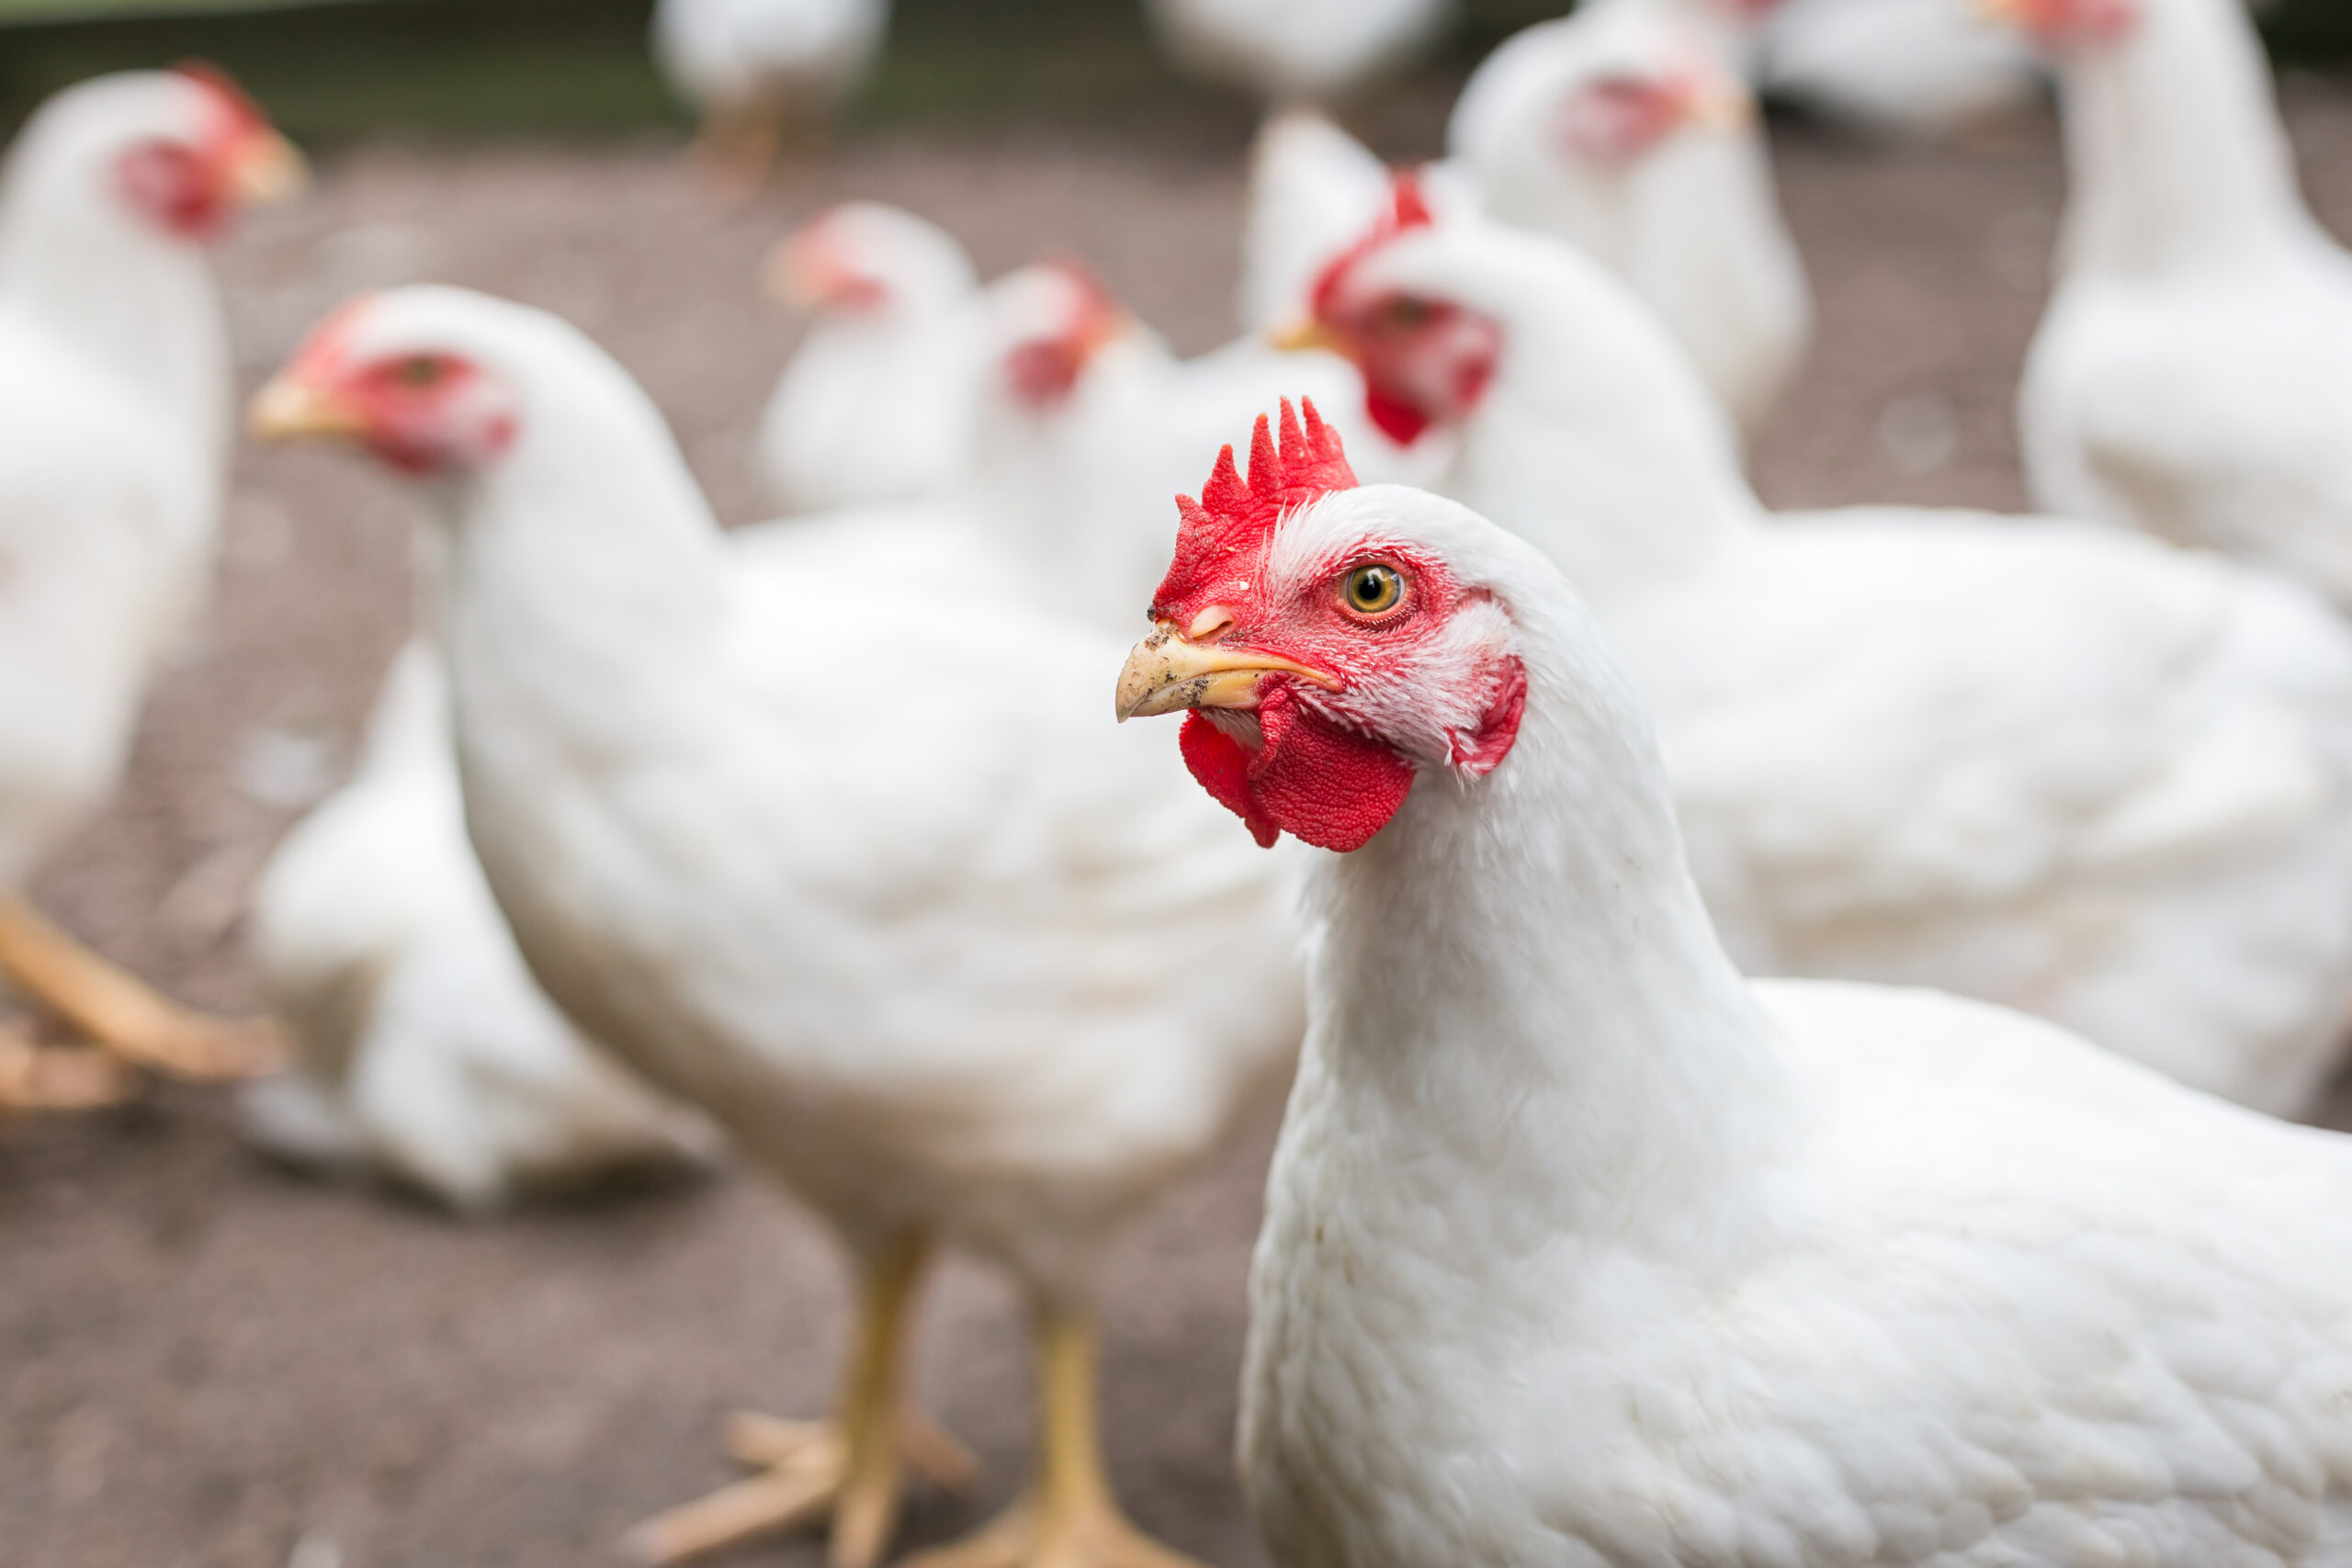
[2004, 0, 2352, 609]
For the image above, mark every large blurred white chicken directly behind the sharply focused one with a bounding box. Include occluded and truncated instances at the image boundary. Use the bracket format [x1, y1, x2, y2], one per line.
[1319, 184, 2352, 1112]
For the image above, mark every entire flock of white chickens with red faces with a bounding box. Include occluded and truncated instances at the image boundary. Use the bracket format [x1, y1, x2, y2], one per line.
[14, 0, 2352, 1568]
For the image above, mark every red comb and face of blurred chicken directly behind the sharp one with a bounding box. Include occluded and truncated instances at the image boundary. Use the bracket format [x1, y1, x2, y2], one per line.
[1315, 172, 1503, 446]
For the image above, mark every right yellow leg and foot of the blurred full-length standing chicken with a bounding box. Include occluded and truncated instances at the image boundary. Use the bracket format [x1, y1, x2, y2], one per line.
[906, 1309, 1200, 1568]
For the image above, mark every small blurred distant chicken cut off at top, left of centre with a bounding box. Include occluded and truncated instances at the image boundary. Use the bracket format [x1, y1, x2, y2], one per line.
[654, 0, 889, 197]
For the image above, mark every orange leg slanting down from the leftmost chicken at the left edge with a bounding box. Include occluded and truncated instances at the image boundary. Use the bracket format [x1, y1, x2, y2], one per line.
[0, 894, 285, 1081]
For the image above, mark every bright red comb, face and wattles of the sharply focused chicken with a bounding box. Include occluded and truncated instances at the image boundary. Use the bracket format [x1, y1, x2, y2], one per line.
[1152, 402, 1526, 851]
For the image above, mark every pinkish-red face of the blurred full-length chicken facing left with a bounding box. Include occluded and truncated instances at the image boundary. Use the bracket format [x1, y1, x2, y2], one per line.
[287, 301, 517, 478]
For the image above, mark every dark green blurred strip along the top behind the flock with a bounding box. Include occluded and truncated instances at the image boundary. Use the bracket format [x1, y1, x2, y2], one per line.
[0, 0, 2352, 141]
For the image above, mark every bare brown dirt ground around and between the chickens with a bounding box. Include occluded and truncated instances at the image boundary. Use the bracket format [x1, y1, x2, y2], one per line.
[14, 80, 2352, 1568]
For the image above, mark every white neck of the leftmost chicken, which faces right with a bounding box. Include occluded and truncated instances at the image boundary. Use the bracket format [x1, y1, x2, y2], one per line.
[0, 133, 231, 466]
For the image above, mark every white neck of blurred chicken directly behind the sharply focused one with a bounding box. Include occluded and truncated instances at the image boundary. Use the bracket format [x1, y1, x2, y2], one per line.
[1442, 231, 1761, 609]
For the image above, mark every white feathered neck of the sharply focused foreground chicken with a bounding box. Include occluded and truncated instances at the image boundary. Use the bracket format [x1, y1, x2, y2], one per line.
[1307, 588, 1790, 1274]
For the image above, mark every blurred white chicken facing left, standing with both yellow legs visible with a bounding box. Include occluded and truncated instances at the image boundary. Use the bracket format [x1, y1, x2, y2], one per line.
[254, 287, 1298, 1568]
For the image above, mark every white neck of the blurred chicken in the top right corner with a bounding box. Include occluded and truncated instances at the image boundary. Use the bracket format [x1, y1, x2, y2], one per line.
[2063, 0, 2317, 275]
